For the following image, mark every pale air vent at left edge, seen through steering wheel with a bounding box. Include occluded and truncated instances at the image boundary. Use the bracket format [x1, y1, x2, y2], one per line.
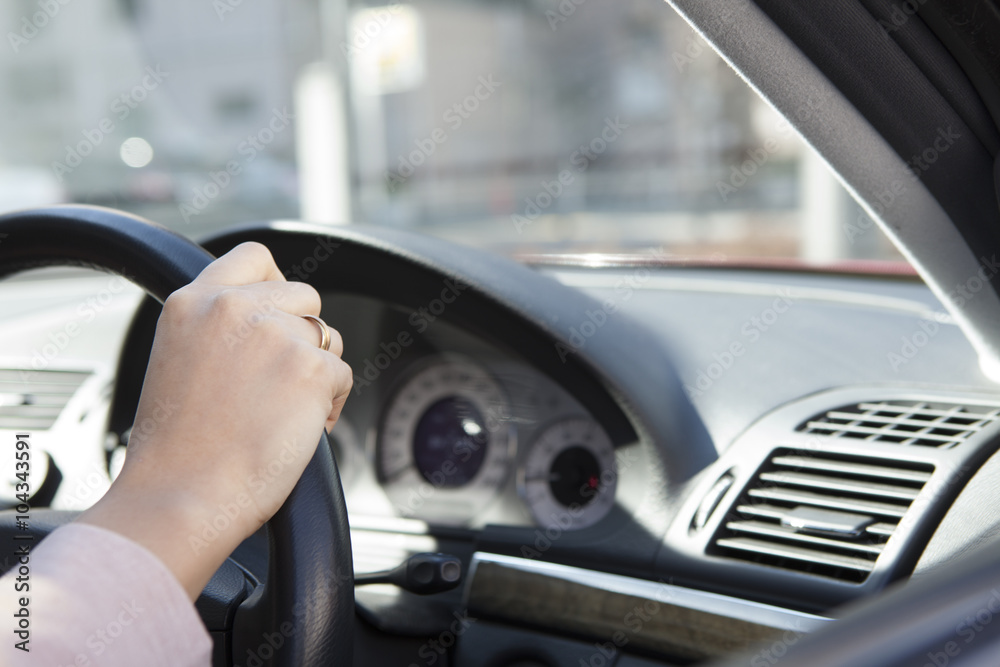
[0, 369, 90, 431]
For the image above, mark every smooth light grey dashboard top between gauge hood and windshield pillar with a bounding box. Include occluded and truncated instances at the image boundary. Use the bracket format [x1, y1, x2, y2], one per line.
[551, 268, 1000, 451]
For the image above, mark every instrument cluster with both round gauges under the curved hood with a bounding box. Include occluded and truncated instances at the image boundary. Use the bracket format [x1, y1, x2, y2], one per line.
[356, 354, 616, 530]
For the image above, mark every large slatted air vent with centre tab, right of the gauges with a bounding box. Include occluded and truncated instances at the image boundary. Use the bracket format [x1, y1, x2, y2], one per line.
[711, 449, 934, 582]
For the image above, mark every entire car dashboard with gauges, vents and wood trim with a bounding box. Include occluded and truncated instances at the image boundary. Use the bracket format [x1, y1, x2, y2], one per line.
[0, 224, 1000, 666]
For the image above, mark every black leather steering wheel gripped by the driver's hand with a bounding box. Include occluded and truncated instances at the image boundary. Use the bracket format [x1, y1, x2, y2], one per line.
[0, 206, 354, 667]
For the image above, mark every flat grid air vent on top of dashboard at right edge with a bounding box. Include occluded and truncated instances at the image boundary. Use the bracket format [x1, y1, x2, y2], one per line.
[798, 401, 1000, 449]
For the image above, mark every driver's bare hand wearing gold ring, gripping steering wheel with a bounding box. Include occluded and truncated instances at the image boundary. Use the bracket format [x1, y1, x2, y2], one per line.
[79, 243, 352, 599]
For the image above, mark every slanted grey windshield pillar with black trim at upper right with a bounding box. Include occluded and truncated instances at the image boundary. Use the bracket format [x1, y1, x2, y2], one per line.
[668, 0, 1000, 381]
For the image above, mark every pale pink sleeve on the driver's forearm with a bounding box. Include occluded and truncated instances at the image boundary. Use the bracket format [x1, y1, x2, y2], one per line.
[0, 523, 212, 667]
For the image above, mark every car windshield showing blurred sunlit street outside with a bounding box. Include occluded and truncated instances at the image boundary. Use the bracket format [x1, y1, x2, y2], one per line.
[0, 0, 901, 263]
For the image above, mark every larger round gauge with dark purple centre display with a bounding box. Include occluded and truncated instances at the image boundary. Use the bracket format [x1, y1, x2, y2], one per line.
[376, 358, 514, 525]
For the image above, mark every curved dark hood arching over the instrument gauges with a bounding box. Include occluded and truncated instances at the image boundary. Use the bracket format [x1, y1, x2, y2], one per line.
[191, 221, 716, 485]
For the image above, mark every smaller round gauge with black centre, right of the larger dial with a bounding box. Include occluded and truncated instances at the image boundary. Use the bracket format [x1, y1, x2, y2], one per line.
[518, 417, 617, 529]
